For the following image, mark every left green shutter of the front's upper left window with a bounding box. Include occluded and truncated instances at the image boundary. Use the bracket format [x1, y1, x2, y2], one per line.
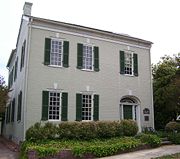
[44, 38, 51, 65]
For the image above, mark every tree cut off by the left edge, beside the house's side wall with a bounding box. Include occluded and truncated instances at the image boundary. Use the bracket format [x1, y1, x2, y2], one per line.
[0, 75, 9, 115]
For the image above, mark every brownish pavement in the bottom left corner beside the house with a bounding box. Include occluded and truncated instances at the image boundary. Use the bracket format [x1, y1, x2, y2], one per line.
[0, 136, 19, 159]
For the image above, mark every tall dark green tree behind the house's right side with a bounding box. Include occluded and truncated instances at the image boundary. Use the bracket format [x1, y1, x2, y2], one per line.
[153, 54, 180, 129]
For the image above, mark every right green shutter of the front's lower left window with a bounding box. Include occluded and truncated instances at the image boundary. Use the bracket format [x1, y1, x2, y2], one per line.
[61, 92, 68, 121]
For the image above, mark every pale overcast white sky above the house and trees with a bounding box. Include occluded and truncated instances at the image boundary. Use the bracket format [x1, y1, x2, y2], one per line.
[0, 0, 180, 81]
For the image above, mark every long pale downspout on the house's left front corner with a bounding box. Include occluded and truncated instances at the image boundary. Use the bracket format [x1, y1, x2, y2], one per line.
[23, 17, 32, 140]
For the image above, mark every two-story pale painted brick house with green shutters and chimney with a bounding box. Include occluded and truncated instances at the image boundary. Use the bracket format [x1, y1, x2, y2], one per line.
[4, 2, 154, 142]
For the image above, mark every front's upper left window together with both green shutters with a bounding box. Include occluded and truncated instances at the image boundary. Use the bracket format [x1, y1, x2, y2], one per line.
[44, 38, 69, 67]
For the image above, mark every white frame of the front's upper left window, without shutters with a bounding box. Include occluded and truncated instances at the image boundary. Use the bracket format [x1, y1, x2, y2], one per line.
[49, 38, 64, 67]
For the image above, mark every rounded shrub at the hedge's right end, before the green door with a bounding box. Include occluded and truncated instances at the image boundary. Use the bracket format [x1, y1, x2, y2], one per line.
[121, 120, 138, 136]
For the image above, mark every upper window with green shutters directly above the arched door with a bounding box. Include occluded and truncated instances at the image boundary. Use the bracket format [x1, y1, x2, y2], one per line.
[120, 51, 138, 76]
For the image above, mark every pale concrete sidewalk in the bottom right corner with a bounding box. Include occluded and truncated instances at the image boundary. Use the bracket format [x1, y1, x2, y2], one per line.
[101, 145, 180, 159]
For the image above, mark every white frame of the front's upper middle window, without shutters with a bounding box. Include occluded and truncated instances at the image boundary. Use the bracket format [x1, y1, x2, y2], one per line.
[82, 43, 94, 71]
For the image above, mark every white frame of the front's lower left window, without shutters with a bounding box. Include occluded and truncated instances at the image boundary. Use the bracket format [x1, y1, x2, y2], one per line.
[48, 90, 62, 121]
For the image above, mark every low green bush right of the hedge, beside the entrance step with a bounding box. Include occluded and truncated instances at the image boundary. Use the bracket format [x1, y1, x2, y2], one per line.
[136, 133, 161, 147]
